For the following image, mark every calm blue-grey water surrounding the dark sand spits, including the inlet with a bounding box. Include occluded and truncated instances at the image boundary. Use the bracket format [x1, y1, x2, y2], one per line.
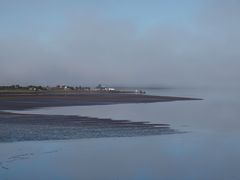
[0, 88, 240, 180]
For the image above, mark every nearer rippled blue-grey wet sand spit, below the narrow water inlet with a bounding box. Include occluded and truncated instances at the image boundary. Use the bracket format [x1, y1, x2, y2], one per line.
[0, 113, 179, 142]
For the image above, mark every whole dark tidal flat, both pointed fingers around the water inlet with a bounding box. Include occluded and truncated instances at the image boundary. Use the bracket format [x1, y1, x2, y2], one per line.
[0, 94, 200, 143]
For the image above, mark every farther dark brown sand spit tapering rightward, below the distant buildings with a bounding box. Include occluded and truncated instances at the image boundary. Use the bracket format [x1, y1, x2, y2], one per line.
[0, 93, 202, 110]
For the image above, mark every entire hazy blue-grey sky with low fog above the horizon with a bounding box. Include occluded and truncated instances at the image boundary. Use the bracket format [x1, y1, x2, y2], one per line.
[0, 0, 240, 87]
